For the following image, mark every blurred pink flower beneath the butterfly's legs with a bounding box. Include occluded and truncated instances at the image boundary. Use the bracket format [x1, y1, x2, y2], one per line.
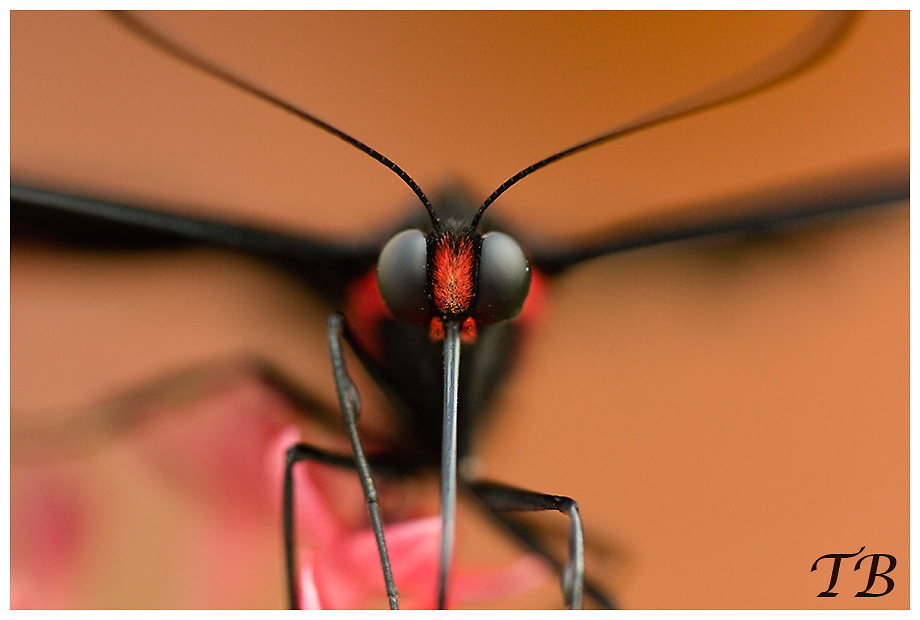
[10, 368, 549, 609]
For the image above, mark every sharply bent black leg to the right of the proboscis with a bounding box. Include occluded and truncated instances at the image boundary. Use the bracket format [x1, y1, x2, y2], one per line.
[467, 481, 585, 609]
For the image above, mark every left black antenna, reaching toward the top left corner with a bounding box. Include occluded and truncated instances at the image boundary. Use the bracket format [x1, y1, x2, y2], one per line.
[109, 11, 441, 232]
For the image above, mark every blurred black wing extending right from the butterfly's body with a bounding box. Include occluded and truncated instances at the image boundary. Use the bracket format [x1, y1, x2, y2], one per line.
[528, 160, 910, 275]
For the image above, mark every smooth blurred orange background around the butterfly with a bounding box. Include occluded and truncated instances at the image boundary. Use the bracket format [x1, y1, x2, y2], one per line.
[10, 12, 910, 608]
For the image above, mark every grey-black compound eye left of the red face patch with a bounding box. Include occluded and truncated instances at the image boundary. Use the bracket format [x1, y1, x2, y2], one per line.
[377, 230, 431, 323]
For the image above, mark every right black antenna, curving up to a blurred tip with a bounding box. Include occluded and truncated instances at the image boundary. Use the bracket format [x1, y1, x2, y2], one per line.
[470, 11, 856, 230]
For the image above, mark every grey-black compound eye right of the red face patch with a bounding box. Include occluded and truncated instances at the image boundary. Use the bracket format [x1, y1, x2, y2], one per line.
[474, 232, 530, 324]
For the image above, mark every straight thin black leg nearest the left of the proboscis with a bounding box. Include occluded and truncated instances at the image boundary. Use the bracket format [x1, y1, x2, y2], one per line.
[324, 314, 399, 609]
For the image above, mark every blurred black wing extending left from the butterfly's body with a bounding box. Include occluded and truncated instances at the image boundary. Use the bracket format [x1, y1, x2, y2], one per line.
[10, 184, 379, 295]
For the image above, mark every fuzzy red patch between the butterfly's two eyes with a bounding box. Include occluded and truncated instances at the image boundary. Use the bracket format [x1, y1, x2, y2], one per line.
[431, 234, 476, 316]
